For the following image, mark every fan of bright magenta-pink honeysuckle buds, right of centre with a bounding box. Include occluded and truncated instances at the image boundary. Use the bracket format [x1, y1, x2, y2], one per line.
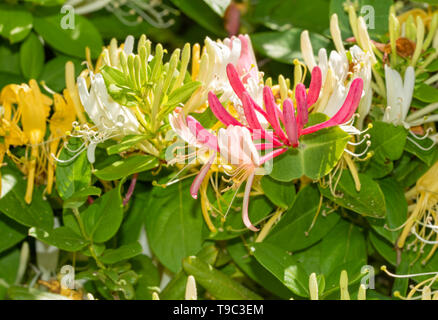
[208, 64, 363, 148]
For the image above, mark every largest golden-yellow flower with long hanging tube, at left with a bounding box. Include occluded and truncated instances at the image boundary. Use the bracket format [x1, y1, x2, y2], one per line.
[18, 79, 52, 203]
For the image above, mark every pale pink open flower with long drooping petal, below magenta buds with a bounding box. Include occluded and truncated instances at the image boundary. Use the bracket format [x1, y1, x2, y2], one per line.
[218, 125, 287, 231]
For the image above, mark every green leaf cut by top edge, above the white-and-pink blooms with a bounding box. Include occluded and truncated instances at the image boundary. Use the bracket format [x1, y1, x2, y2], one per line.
[171, 0, 226, 36]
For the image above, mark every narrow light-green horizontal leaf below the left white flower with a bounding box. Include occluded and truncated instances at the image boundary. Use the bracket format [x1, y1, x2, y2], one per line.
[93, 155, 158, 180]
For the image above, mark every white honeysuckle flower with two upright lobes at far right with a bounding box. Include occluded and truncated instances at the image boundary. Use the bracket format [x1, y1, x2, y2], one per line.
[383, 65, 415, 127]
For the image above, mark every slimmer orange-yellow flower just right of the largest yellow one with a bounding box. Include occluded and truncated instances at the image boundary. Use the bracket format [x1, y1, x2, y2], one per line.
[47, 89, 76, 194]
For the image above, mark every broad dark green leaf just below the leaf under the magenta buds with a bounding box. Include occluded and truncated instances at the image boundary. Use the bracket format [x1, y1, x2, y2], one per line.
[264, 186, 339, 251]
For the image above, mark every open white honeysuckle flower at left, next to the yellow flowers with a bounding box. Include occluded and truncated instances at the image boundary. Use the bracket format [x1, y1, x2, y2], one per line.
[72, 73, 141, 163]
